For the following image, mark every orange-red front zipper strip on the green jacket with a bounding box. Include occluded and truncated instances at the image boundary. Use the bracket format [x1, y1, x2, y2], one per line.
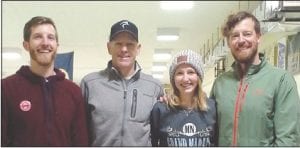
[232, 79, 248, 146]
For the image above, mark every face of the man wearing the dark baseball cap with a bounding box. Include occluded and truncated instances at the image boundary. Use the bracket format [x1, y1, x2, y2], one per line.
[107, 32, 141, 71]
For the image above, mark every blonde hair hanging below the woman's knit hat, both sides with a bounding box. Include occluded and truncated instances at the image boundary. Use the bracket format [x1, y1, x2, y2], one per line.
[167, 79, 208, 111]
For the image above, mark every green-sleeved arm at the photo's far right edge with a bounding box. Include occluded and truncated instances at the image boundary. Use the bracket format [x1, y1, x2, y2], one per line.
[274, 73, 300, 146]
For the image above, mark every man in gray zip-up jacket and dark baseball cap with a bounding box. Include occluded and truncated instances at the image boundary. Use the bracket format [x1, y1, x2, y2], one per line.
[81, 20, 163, 146]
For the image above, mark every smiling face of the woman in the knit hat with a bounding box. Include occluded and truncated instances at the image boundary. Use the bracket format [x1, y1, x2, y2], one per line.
[174, 64, 199, 96]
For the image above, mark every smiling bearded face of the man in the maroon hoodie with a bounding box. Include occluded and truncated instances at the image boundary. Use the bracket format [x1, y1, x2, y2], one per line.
[23, 24, 58, 66]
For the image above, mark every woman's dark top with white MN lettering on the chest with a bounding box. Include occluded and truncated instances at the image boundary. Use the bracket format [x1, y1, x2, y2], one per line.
[151, 99, 216, 147]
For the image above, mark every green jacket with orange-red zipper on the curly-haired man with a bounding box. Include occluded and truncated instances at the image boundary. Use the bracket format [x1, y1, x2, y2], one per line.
[211, 54, 300, 146]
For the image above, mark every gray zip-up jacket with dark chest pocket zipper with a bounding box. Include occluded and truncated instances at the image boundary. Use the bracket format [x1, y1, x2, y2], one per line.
[81, 61, 163, 146]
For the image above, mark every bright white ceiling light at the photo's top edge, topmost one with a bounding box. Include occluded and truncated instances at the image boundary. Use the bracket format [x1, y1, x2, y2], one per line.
[160, 1, 194, 10]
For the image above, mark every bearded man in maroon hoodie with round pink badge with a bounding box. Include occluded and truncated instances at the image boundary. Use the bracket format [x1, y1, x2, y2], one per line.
[1, 16, 88, 146]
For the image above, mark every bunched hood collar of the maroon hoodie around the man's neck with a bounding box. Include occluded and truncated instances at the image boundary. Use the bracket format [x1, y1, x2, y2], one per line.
[17, 65, 65, 83]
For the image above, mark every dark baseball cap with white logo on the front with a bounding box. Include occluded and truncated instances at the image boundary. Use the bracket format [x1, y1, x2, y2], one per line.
[109, 20, 139, 42]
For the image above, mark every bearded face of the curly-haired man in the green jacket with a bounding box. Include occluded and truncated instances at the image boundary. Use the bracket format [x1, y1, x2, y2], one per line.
[227, 18, 260, 63]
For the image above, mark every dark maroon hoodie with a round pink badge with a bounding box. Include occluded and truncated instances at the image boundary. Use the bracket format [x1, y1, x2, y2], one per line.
[1, 66, 88, 146]
